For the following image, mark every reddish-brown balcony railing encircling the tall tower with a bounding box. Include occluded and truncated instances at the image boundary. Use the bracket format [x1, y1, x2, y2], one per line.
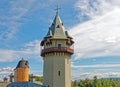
[41, 47, 74, 56]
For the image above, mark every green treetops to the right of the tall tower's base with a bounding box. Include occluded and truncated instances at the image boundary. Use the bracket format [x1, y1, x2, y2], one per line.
[72, 76, 120, 87]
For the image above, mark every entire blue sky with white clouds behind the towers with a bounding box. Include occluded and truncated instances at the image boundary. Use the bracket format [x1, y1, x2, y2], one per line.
[0, 0, 120, 80]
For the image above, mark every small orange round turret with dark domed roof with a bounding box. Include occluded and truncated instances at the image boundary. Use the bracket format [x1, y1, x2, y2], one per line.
[14, 59, 29, 82]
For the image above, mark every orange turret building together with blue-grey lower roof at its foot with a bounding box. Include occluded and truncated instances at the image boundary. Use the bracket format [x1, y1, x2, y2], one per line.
[6, 58, 43, 87]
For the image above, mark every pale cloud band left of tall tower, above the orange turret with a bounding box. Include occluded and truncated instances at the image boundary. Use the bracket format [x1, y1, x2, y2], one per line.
[0, 40, 40, 62]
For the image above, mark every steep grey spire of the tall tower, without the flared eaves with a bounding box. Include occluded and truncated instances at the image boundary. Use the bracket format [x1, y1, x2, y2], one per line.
[46, 11, 67, 39]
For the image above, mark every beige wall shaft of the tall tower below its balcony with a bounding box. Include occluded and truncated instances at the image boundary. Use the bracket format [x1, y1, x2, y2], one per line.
[44, 53, 71, 87]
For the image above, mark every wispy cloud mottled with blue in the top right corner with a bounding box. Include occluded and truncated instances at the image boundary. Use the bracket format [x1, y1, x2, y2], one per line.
[75, 0, 120, 20]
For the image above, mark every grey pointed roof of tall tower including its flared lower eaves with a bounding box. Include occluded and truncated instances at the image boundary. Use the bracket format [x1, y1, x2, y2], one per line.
[40, 11, 74, 46]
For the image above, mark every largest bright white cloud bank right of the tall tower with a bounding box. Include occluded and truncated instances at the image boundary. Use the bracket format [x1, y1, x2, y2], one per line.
[69, 0, 120, 59]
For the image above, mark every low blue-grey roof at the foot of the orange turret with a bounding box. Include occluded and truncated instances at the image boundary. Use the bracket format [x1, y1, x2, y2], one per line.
[7, 82, 45, 87]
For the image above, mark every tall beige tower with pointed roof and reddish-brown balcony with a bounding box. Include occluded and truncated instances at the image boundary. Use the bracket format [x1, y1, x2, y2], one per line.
[41, 11, 74, 87]
